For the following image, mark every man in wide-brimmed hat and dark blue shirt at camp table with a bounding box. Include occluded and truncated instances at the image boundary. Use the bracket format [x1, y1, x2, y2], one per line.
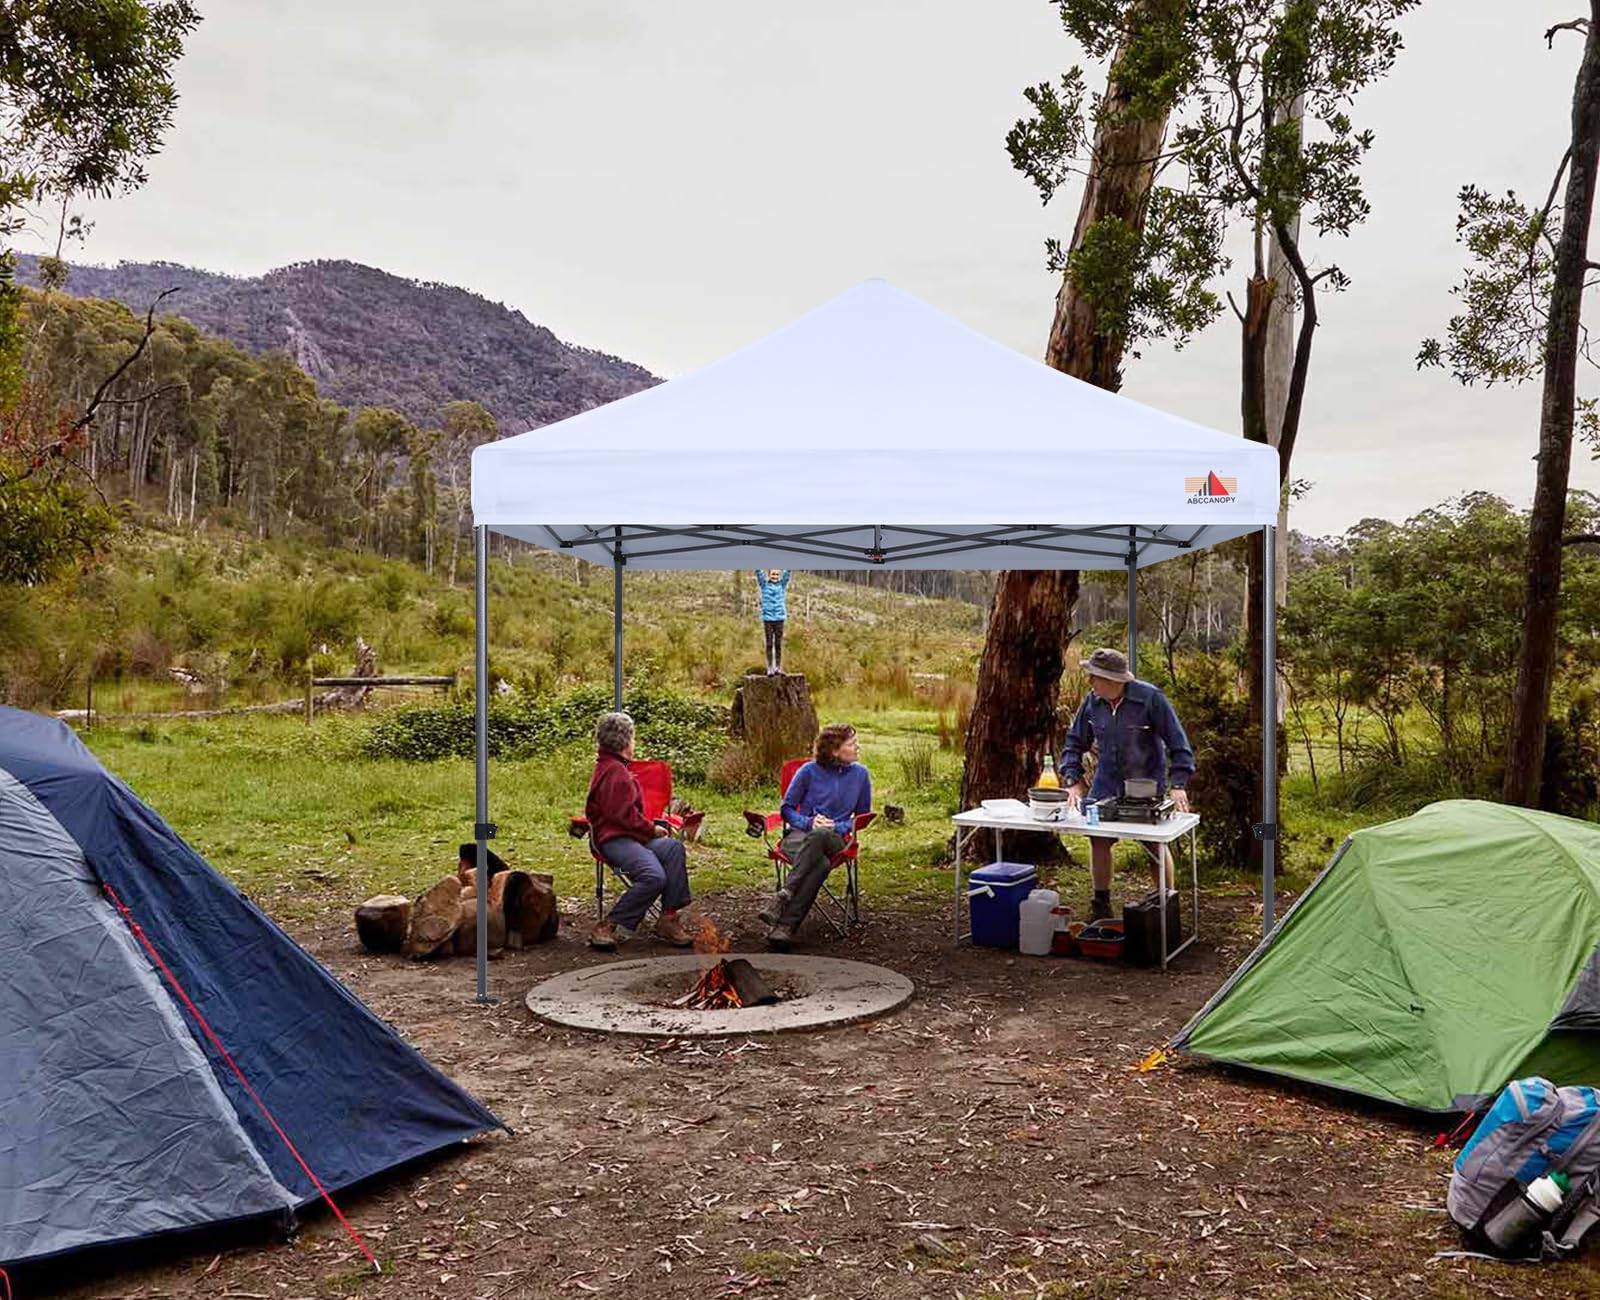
[1061, 648, 1195, 921]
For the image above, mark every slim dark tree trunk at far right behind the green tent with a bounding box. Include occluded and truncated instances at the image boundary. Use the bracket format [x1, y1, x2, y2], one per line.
[1502, 0, 1600, 807]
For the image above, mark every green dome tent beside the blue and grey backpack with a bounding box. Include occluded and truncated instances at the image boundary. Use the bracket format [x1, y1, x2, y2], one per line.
[1173, 799, 1600, 1111]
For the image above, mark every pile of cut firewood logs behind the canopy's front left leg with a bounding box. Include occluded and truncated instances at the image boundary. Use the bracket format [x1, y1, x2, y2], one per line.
[355, 844, 560, 961]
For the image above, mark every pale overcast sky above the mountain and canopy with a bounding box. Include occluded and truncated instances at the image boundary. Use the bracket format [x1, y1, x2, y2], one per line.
[31, 0, 1600, 533]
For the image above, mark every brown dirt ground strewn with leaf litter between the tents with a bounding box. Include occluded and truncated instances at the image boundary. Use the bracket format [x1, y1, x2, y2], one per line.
[28, 895, 1600, 1300]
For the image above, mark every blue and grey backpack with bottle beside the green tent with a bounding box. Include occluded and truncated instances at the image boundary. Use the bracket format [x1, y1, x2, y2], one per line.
[1445, 1079, 1600, 1255]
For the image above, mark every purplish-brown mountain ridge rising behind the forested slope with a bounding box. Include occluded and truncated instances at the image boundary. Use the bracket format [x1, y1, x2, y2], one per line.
[18, 255, 659, 434]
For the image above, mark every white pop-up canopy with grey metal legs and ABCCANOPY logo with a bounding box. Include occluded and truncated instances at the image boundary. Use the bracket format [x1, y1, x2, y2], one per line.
[472, 280, 1278, 999]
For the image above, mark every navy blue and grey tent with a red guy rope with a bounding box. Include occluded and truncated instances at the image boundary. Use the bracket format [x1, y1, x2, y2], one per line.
[0, 708, 501, 1265]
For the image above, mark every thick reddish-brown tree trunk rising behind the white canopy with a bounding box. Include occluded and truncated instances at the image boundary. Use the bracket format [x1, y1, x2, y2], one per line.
[962, 0, 1187, 852]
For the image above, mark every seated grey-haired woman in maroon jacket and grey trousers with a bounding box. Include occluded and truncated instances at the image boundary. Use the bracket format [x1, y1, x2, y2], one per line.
[584, 712, 693, 953]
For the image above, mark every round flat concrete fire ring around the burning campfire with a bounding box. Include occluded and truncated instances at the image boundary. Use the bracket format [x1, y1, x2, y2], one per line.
[528, 953, 912, 1037]
